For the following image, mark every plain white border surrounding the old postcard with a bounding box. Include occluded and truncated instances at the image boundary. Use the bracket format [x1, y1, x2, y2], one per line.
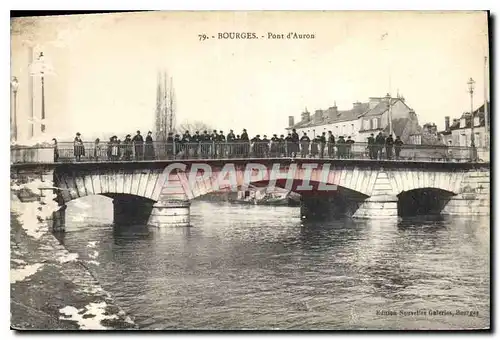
[0, 0, 500, 338]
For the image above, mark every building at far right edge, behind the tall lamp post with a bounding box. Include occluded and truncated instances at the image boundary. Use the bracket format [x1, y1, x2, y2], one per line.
[439, 103, 491, 148]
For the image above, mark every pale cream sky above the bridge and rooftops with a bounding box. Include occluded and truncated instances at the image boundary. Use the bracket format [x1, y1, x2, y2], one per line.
[11, 11, 488, 140]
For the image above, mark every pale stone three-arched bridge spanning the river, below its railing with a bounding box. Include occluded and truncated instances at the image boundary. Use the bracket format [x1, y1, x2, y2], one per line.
[11, 159, 490, 230]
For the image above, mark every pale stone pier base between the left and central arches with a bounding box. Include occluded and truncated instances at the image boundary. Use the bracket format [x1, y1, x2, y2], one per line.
[148, 200, 191, 228]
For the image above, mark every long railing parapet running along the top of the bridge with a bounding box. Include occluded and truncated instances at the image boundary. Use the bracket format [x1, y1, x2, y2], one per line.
[11, 142, 490, 164]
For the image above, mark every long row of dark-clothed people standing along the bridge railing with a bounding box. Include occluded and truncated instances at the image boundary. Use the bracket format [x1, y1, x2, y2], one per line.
[54, 129, 403, 161]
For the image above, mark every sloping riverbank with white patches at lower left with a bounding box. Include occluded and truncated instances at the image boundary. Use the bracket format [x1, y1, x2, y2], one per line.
[10, 195, 136, 330]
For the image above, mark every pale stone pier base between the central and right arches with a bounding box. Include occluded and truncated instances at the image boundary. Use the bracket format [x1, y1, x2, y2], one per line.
[352, 195, 398, 219]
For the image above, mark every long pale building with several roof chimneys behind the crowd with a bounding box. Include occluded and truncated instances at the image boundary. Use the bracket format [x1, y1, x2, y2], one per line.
[287, 95, 422, 144]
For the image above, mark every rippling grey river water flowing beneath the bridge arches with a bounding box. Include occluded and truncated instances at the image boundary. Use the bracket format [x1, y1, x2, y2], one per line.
[59, 197, 490, 329]
